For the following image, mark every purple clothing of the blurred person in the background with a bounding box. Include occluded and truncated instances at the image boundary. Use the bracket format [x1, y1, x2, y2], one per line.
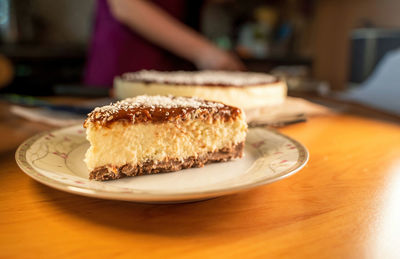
[84, 0, 184, 87]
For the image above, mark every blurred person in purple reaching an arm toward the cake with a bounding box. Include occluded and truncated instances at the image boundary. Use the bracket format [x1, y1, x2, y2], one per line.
[84, 0, 244, 87]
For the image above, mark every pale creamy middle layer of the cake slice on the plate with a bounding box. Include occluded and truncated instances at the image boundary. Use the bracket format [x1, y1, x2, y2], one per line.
[85, 118, 247, 171]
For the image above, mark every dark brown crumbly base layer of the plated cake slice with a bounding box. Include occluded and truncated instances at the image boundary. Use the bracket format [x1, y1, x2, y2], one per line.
[89, 142, 244, 181]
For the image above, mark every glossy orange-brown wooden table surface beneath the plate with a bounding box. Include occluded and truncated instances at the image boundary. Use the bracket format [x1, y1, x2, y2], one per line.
[0, 100, 400, 258]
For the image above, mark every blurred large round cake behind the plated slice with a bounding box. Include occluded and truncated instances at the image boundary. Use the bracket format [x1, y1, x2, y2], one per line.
[114, 70, 287, 109]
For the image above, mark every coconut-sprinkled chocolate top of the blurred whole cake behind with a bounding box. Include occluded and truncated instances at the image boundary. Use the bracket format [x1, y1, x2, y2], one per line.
[122, 70, 276, 86]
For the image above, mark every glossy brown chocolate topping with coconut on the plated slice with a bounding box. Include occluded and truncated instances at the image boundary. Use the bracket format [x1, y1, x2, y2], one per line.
[84, 95, 242, 127]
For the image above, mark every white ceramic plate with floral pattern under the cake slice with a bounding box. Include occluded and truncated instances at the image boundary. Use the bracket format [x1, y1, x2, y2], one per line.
[15, 125, 308, 203]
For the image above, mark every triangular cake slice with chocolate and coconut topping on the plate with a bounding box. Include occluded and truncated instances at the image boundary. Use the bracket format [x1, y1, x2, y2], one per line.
[84, 96, 247, 180]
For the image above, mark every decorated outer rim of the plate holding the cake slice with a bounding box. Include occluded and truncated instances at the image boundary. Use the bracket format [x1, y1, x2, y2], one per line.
[15, 125, 310, 203]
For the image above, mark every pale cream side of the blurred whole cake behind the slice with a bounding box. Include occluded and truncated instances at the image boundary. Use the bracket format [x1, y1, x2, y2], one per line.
[114, 78, 287, 109]
